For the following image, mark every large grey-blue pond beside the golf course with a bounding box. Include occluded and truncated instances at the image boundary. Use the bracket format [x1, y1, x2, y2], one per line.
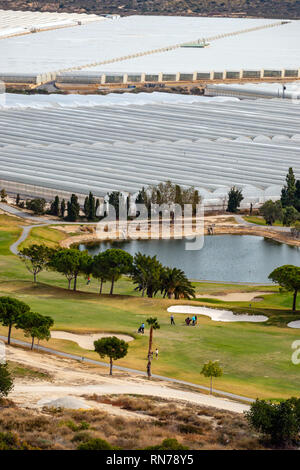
[79, 235, 300, 283]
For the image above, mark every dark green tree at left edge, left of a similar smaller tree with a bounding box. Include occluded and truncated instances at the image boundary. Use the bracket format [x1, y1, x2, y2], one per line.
[0, 296, 30, 344]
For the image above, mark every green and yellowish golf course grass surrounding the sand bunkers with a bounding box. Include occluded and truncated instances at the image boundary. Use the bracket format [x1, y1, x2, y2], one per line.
[0, 216, 300, 398]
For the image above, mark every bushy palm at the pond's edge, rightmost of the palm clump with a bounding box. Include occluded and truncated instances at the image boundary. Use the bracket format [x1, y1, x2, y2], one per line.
[161, 268, 195, 299]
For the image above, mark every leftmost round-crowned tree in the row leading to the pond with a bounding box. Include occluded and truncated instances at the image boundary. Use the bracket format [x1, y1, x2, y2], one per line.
[19, 244, 55, 283]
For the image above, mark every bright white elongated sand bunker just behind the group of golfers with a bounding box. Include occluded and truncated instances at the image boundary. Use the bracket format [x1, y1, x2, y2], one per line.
[168, 305, 268, 323]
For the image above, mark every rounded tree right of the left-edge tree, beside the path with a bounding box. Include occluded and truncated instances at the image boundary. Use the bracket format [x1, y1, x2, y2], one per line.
[18, 312, 54, 349]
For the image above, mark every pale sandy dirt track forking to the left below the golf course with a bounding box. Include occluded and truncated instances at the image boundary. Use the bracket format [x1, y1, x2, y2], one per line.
[7, 346, 249, 413]
